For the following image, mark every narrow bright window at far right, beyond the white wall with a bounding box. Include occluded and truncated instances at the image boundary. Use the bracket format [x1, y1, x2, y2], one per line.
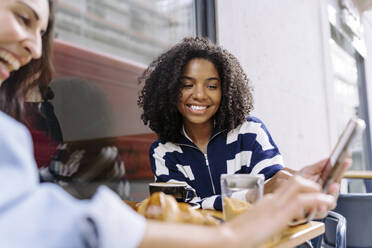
[330, 25, 371, 192]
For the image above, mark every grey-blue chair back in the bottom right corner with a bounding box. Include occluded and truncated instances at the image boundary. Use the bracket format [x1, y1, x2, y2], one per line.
[334, 193, 372, 248]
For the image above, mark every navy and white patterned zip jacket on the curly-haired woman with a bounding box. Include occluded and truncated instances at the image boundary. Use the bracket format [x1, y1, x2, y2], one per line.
[150, 116, 284, 210]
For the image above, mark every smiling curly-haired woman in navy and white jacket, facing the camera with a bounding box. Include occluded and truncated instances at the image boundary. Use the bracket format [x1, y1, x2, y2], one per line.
[138, 38, 283, 210]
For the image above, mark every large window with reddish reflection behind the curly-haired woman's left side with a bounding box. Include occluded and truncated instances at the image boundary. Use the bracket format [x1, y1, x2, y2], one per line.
[51, 0, 216, 184]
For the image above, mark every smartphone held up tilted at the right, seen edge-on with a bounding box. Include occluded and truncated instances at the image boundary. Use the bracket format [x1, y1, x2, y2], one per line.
[318, 118, 366, 193]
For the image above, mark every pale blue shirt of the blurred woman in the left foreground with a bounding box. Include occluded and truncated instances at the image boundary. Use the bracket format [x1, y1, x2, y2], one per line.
[0, 111, 146, 248]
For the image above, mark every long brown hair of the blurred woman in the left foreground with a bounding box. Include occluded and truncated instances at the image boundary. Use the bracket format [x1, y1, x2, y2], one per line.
[0, 0, 55, 122]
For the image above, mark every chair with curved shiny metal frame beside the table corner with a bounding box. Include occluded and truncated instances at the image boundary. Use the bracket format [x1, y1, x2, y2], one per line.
[311, 211, 346, 248]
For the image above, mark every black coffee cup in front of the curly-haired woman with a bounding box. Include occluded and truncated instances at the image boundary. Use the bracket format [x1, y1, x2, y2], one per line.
[149, 182, 196, 202]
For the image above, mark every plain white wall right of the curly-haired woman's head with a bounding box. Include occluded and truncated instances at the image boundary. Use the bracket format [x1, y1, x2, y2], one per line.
[217, 0, 342, 169]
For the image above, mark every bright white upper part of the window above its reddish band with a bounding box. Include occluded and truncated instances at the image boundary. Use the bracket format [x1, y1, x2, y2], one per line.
[56, 0, 196, 64]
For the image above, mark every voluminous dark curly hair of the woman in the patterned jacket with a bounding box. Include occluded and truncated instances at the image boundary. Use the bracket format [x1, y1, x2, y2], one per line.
[138, 35, 253, 142]
